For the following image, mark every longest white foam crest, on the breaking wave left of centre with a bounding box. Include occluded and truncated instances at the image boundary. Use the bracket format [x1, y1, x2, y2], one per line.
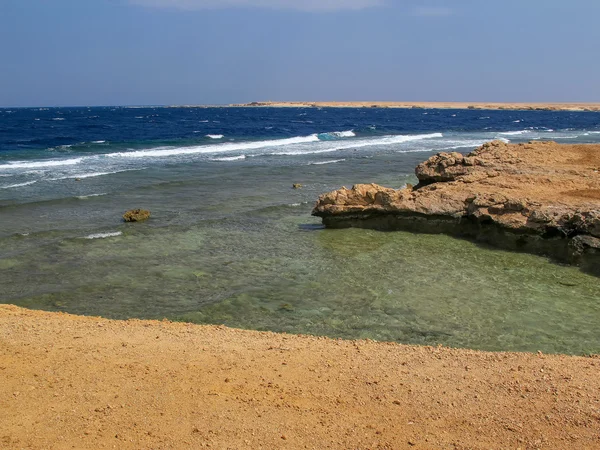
[108, 134, 319, 158]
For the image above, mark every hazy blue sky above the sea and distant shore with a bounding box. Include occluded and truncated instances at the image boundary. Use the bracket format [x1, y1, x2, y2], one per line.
[0, 0, 600, 107]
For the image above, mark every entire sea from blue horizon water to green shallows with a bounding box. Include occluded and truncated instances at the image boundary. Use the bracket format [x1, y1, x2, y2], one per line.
[0, 107, 600, 354]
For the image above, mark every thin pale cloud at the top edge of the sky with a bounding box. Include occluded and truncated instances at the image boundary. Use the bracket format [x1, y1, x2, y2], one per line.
[129, 0, 385, 11]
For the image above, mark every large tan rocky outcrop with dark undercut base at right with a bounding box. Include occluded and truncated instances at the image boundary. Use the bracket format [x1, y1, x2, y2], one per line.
[313, 141, 600, 273]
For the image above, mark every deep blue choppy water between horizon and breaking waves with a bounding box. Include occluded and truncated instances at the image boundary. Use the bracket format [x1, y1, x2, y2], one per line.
[0, 107, 600, 155]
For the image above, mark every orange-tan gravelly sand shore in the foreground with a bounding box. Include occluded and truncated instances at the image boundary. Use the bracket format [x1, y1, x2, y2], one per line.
[0, 305, 600, 449]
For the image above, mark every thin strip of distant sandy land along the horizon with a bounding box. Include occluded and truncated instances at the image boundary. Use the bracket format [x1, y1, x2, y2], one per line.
[229, 102, 600, 111]
